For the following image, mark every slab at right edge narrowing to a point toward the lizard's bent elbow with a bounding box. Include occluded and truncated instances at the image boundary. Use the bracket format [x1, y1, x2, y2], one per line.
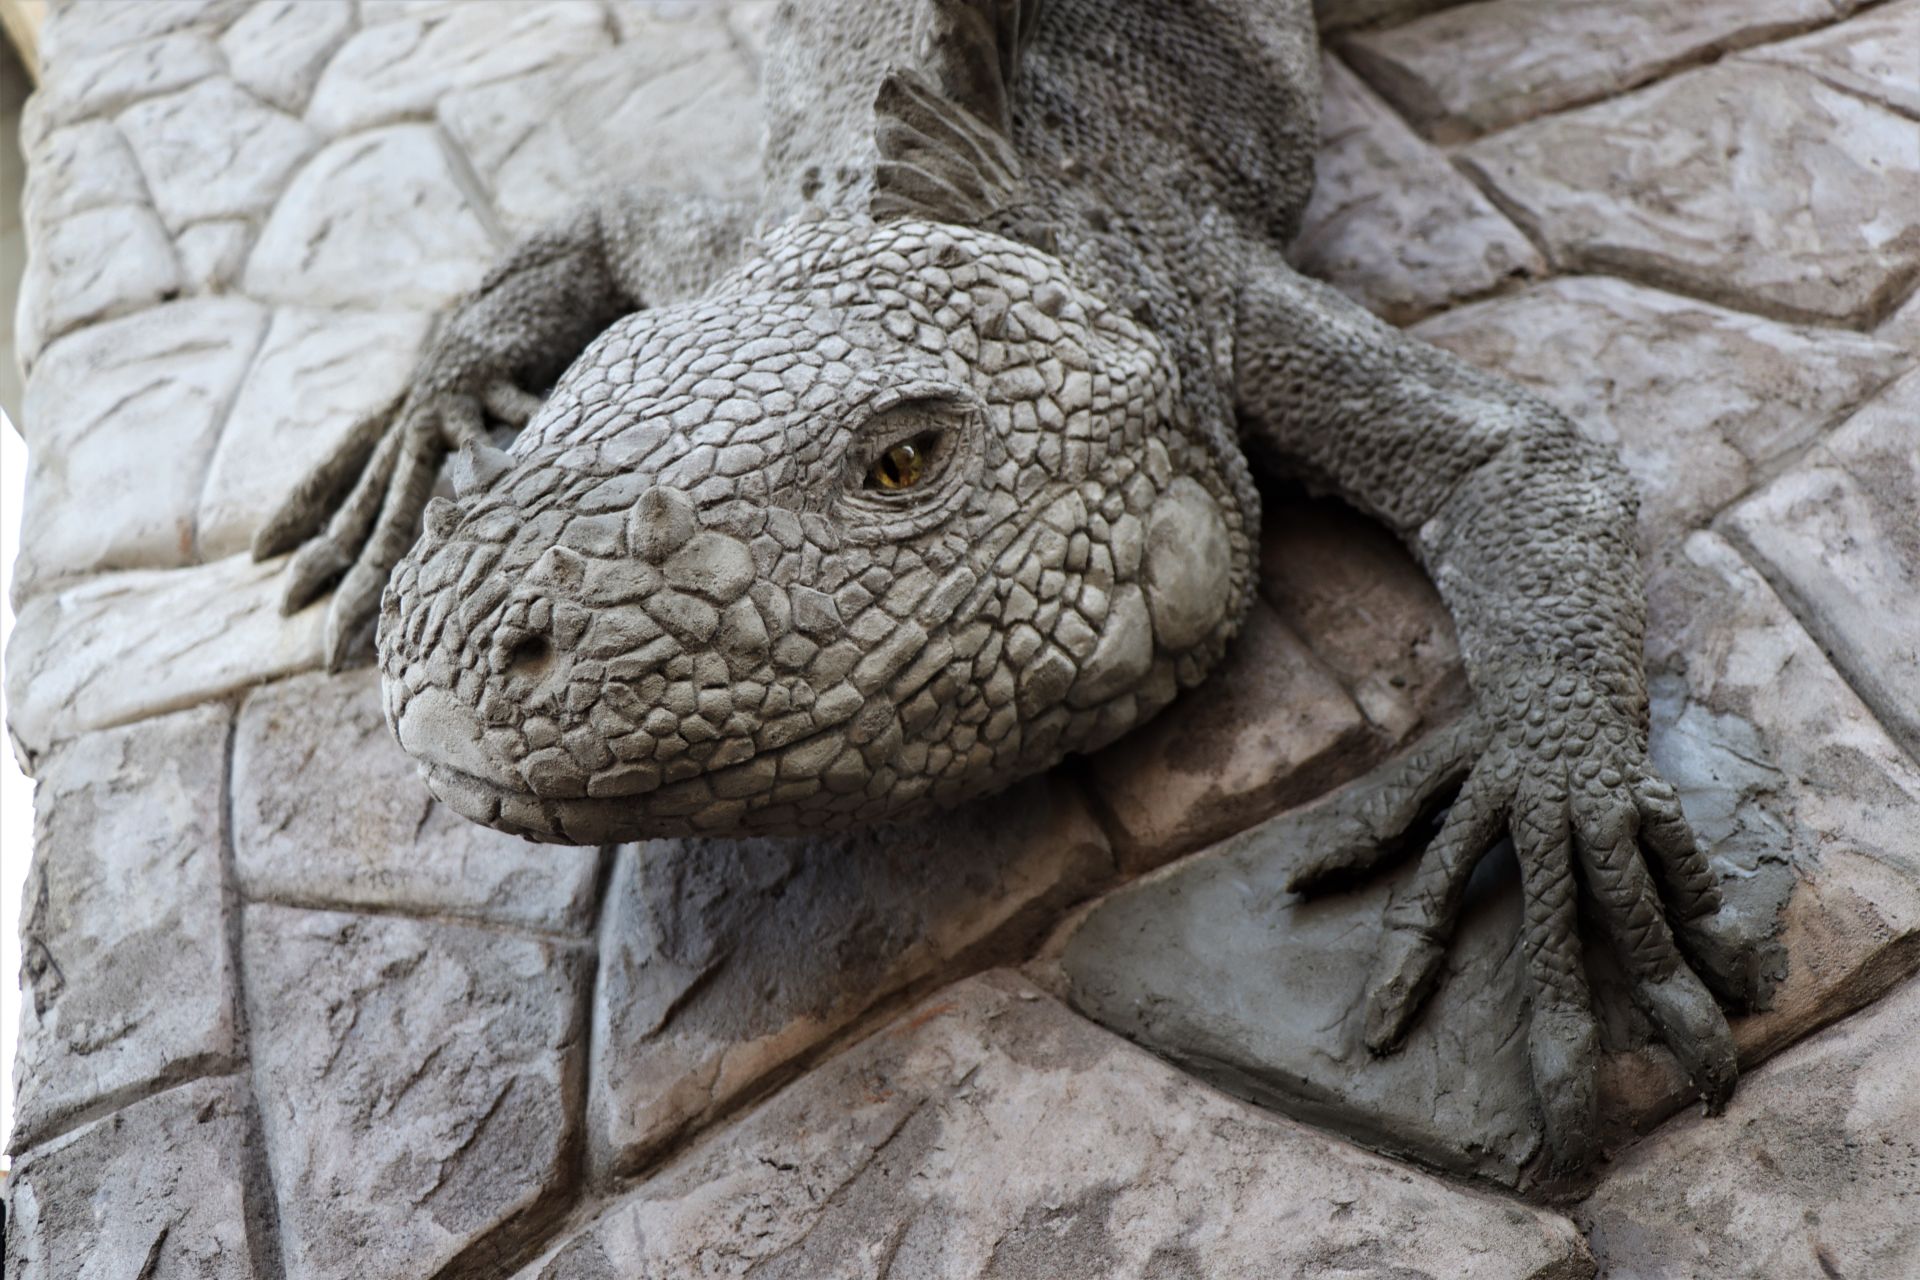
[1728, 372, 1920, 760]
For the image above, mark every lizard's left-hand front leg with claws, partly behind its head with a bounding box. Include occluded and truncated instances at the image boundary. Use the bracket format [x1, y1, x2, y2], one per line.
[253, 188, 751, 670]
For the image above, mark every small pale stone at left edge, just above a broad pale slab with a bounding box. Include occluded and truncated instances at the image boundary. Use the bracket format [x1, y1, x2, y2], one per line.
[15, 203, 180, 370]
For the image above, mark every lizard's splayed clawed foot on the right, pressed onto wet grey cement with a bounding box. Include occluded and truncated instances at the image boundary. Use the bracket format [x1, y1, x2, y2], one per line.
[1288, 676, 1778, 1169]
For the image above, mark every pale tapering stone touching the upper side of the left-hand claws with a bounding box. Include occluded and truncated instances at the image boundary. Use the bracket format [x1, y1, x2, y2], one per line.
[200, 307, 432, 557]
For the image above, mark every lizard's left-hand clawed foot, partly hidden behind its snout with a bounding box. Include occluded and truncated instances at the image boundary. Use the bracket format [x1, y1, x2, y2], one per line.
[253, 380, 540, 672]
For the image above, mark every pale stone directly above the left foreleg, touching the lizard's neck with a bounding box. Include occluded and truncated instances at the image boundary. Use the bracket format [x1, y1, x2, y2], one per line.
[440, 35, 762, 232]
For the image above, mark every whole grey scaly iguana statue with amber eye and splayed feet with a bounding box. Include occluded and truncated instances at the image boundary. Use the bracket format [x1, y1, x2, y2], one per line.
[255, 0, 1751, 1165]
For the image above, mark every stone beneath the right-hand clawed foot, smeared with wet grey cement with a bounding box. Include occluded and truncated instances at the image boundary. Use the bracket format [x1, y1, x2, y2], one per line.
[1058, 533, 1920, 1186]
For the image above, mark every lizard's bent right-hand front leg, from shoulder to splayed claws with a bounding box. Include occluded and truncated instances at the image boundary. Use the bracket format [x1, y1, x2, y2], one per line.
[1236, 255, 1755, 1167]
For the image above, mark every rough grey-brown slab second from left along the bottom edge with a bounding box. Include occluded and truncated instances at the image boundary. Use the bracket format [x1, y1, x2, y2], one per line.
[242, 906, 588, 1280]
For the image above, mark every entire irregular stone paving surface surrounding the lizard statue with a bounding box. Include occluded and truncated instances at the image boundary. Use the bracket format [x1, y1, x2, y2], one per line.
[6, 0, 1920, 1280]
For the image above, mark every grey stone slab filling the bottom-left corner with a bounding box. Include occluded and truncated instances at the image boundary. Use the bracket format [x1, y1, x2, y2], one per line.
[6, 1077, 278, 1280]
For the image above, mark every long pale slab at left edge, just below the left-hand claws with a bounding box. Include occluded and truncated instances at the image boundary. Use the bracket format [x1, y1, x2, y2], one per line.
[6, 557, 326, 773]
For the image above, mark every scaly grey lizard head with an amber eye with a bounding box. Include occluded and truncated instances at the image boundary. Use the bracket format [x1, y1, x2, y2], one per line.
[378, 221, 1250, 842]
